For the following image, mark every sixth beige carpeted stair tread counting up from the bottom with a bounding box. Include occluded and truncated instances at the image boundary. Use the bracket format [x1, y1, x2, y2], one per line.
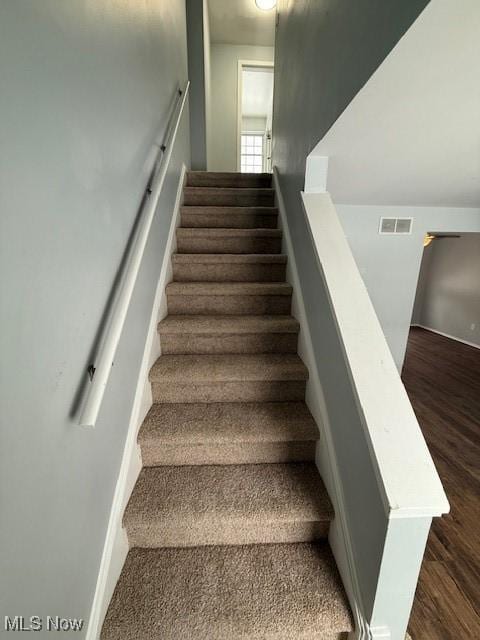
[166, 282, 292, 296]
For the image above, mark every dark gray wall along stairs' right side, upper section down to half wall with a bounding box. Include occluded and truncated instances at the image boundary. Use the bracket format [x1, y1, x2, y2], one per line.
[273, 0, 427, 624]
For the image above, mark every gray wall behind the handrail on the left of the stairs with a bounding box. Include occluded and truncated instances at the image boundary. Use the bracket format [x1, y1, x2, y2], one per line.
[0, 0, 189, 638]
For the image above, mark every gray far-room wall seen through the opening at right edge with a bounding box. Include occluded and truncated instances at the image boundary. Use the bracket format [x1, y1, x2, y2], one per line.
[412, 234, 480, 346]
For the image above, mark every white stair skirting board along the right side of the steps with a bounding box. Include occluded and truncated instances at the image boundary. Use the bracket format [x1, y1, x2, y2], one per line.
[273, 168, 371, 640]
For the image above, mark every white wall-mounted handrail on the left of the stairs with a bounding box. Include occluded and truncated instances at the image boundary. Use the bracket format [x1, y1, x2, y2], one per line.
[79, 82, 190, 427]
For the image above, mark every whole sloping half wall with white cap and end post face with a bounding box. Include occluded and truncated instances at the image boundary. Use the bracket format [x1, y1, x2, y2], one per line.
[301, 192, 449, 640]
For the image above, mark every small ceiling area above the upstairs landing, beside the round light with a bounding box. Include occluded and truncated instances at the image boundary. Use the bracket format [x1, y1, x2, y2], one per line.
[208, 0, 276, 47]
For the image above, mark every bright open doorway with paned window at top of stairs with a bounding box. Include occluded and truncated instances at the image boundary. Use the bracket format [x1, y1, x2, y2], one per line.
[237, 60, 274, 173]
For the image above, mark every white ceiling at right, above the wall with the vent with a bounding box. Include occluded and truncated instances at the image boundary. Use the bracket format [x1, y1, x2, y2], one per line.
[313, 0, 480, 207]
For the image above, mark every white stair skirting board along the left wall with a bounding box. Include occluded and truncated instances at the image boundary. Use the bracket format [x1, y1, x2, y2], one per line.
[86, 165, 187, 640]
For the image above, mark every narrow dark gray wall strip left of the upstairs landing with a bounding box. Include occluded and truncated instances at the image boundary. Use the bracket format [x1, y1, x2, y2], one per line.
[186, 0, 210, 171]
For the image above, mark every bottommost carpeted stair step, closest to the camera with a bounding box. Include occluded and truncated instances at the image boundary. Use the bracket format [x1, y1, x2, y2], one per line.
[101, 542, 352, 640]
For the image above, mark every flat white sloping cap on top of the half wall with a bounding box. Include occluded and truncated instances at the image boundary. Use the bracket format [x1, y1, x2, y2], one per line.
[302, 193, 449, 518]
